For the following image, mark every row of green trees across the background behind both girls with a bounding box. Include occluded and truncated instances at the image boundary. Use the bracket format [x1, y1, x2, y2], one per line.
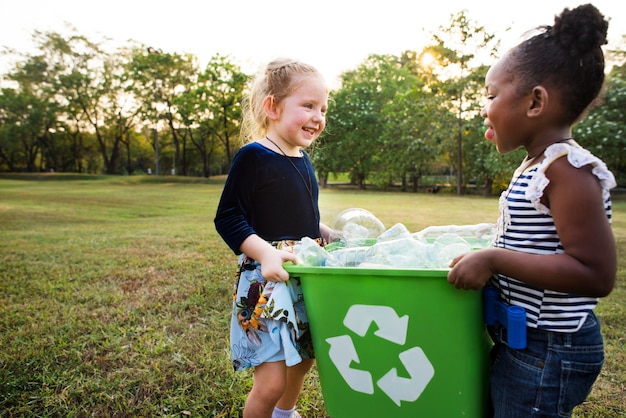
[0, 18, 626, 191]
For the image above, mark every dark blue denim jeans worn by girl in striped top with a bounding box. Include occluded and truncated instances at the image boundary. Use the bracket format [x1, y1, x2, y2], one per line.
[489, 312, 604, 418]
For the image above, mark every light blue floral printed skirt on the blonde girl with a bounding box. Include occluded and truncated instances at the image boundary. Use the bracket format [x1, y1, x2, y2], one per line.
[230, 250, 315, 370]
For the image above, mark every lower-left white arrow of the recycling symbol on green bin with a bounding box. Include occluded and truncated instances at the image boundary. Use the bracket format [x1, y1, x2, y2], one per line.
[326, 335, 374, 395]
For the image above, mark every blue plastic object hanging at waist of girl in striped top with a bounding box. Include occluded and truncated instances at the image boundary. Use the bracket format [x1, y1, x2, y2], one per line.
[483, 286, 526, 349]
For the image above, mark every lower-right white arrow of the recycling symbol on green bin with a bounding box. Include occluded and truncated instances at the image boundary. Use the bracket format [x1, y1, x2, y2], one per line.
[376, 347, 435, 406]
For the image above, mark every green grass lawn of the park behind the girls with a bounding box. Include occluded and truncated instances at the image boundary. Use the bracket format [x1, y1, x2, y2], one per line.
[0, 175, 626, 418]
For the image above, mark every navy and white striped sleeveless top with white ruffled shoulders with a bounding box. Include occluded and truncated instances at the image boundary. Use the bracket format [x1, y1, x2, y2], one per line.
[492, 141, 616, 332]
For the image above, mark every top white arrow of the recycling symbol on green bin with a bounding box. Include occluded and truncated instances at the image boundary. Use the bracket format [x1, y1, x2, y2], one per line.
[343, 305, 409, 345]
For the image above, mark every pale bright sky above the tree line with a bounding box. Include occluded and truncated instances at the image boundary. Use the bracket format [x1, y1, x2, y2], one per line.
[0, 0, 626, 84]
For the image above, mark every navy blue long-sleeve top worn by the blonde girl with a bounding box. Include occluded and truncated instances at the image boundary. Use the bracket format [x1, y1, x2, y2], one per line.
[214, 142, 321, 255]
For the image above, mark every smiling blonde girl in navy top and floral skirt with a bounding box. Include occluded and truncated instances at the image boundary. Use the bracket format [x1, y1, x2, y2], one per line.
[215, 59, 330, 418]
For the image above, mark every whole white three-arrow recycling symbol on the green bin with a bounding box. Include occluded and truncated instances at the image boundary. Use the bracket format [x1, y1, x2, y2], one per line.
[326, 305, 435, 406]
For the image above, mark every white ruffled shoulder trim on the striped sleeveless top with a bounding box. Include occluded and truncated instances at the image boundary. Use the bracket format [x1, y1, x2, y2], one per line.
[526, 141, 617, 214]
